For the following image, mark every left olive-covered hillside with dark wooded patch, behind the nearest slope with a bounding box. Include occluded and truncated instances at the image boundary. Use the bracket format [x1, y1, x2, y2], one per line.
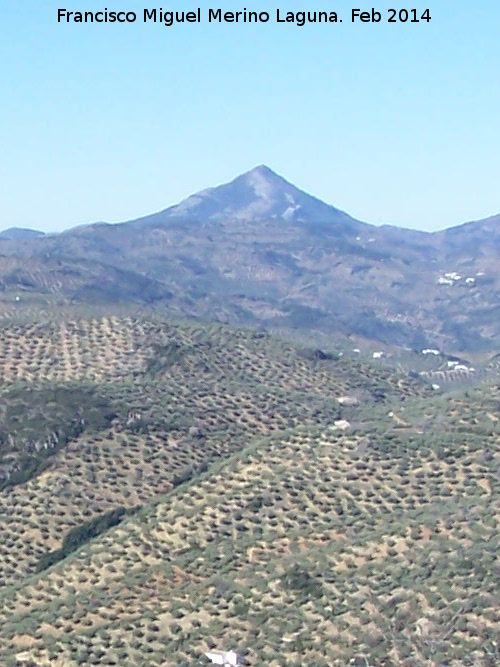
[0, 317, 429, 584]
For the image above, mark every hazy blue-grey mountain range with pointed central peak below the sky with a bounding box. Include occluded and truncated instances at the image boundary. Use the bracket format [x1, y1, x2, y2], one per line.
[0, 166, 500, 352]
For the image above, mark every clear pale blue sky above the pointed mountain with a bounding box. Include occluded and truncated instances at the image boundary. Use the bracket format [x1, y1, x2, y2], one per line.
[0, 0, 500, 231]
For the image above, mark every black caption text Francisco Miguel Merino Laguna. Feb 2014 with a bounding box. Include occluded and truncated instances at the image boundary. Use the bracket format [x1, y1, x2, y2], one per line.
[57, 7, 431, 27]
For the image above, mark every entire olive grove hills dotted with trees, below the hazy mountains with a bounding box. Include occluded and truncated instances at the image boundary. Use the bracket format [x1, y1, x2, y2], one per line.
[0, 317, 500, 667]
